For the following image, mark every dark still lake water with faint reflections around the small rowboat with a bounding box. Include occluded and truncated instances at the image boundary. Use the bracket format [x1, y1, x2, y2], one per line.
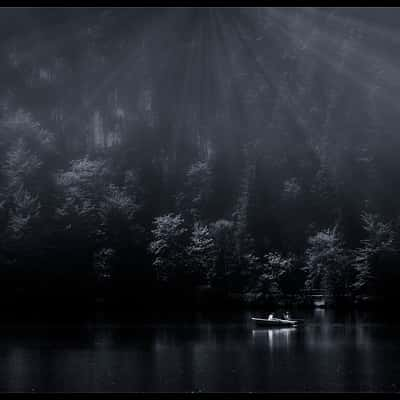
[0, 310, 400, 392]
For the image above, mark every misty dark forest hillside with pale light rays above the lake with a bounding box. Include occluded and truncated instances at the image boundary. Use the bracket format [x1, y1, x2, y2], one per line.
[0, 8, 400, 307]
